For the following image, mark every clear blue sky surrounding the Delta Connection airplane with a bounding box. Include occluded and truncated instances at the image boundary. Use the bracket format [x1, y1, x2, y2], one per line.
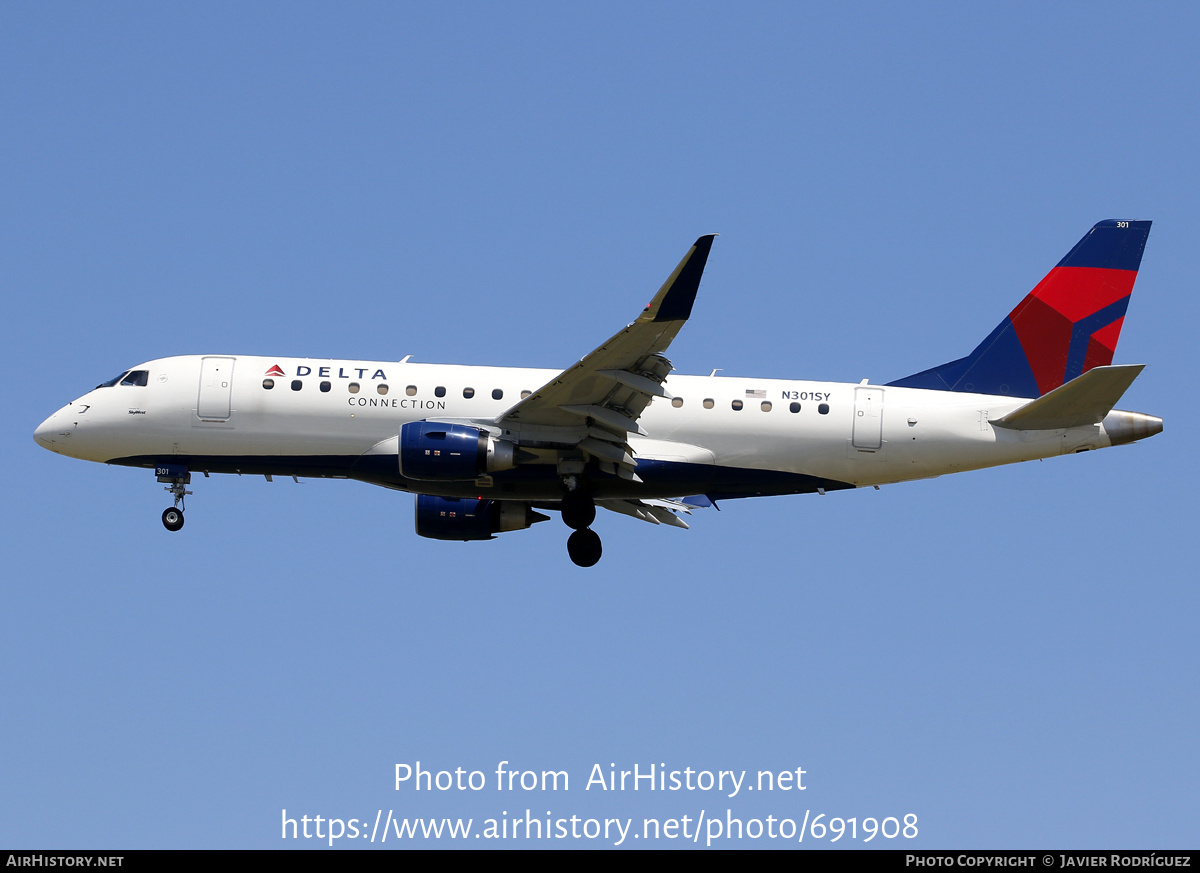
[0, 4, 1200, 848]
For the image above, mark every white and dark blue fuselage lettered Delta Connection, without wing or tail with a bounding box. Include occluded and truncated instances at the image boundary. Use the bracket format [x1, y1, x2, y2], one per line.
[35, 355, 1112, 500]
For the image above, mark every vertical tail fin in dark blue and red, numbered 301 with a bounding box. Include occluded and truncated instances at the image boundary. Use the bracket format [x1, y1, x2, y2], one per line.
[888, 219, 1151, 397]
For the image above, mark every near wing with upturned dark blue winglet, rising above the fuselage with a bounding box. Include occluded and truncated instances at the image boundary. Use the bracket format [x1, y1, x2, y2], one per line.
[496, 234, 716, 477]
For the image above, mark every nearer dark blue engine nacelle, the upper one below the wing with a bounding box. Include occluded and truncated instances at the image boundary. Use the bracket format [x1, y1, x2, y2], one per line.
[400, 421, 516, 481]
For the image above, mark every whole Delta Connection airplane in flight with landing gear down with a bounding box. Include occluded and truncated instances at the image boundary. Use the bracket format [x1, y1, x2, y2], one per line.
[34, 221, 1163, 567]
